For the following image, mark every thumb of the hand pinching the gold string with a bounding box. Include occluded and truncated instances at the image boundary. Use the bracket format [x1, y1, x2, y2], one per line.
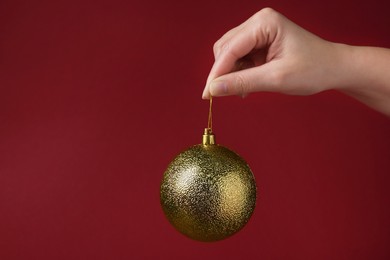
[209, 63, 279, 97]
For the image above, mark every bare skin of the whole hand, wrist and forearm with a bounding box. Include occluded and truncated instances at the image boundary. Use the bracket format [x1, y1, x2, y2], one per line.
[202, 8, 390, 116]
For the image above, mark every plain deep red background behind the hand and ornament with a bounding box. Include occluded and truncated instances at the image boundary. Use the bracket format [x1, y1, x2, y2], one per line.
[0, 0, 390, 260]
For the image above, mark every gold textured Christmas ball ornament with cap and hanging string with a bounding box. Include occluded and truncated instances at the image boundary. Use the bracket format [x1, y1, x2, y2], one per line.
[160, 99, 256, 241]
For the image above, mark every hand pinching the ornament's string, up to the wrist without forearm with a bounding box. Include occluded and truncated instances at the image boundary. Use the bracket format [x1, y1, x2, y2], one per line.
[203, 8, 336, 99]
